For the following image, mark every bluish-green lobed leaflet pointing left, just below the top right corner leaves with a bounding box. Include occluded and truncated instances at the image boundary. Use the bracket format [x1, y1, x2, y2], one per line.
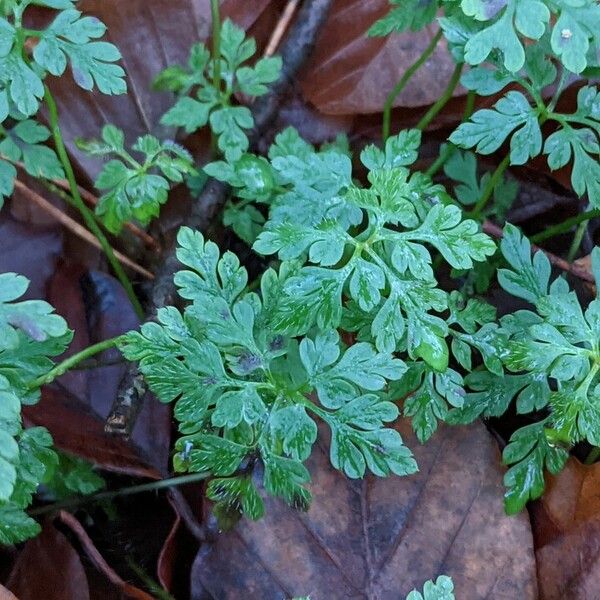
[449, 90, 542, 165]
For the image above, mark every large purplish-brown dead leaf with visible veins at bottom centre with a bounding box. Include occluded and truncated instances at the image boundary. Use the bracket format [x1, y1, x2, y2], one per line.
[191, 422, 537, 600]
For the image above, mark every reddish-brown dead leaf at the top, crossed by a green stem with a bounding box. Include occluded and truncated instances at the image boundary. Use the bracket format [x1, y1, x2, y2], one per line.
[301, 0, 454, 114]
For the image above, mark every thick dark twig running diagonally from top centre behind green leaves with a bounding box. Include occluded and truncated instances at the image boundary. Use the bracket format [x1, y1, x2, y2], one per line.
[105, 0, 333, 437]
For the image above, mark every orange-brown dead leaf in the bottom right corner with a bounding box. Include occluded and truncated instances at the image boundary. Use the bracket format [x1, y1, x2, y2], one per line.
[532, 458, 600, 600]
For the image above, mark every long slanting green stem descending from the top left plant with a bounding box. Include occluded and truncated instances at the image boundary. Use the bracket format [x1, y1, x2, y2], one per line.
[44, 86, 144, 318]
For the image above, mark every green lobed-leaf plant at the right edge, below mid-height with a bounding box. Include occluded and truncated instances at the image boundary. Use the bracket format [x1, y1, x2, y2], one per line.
[450, 225, 600, 513]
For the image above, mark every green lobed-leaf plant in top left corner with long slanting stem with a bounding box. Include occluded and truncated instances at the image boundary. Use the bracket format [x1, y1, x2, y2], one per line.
[0, 0, 143, 316]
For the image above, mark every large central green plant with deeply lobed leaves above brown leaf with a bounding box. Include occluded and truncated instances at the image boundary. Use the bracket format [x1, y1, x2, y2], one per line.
[120, 130, 495, 518]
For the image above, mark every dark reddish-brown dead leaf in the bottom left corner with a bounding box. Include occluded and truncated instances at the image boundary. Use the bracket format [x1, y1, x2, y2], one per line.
[6, 520, 90, 600]
